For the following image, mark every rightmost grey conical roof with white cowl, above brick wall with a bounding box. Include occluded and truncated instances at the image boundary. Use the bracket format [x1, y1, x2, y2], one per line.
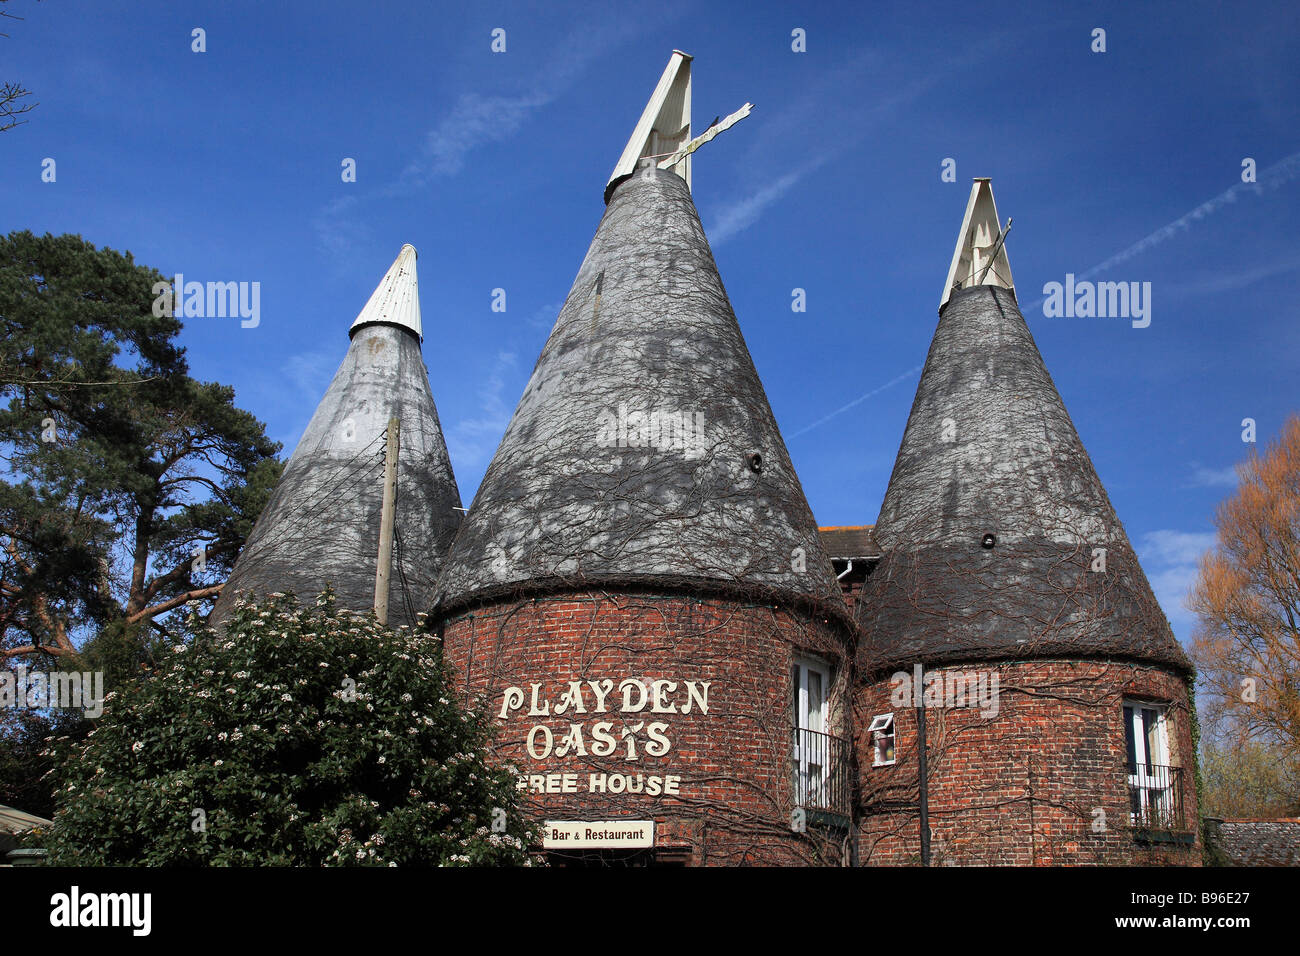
[858, 182, 1187, 672]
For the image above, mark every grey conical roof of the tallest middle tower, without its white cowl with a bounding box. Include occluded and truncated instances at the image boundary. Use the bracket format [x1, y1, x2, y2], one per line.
[438, 166, 845, 624]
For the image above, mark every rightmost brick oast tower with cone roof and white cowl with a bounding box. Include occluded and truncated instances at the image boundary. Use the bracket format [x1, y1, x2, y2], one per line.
[855, 179, 1199, 865]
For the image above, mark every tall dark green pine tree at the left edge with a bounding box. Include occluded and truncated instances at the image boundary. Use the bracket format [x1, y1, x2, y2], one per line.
[0, 232, 281, 658]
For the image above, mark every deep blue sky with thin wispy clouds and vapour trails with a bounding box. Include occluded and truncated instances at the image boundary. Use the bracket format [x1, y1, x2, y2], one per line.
[0, 0, 1300, 640]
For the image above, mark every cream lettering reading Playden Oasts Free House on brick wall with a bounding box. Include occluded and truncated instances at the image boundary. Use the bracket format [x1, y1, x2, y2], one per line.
[499, 678, 712, 796]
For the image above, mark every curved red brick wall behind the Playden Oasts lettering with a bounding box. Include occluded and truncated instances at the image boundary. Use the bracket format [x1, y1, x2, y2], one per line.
[443, 593, 848, 865]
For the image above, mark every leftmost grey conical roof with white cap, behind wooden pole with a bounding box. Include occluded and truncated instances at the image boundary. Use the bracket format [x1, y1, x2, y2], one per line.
[212, 246, 460, 624]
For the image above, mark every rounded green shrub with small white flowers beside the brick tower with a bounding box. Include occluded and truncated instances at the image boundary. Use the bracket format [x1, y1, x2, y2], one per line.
[40, 591, 536, 866]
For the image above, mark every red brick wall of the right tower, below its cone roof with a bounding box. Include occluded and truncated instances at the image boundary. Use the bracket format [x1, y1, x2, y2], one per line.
[854, 661, 1200, 866]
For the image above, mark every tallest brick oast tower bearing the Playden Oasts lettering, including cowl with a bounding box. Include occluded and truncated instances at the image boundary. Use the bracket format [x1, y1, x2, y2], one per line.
[434, 52, 852, 865]
